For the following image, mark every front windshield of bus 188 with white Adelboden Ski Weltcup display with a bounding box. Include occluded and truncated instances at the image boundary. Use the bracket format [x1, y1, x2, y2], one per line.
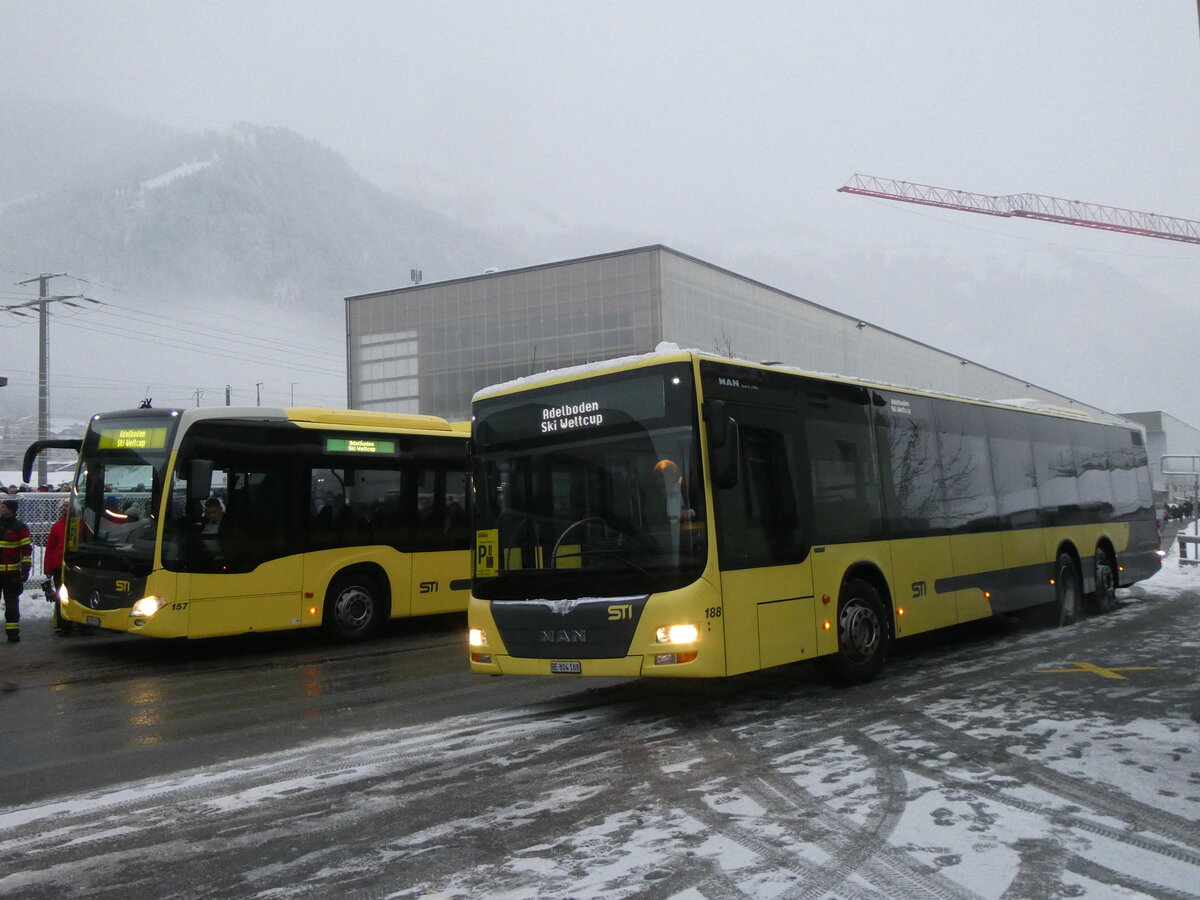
[475, 364, 707, 600]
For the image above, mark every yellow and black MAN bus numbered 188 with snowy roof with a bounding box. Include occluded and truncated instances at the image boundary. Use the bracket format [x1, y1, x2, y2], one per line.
[467, 349, 1160, 683]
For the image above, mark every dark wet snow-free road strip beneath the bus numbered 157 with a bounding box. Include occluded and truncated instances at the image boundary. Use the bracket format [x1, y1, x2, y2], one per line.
[0, 614, 597, 805]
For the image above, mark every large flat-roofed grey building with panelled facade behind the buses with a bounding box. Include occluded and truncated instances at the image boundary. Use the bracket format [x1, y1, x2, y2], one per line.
[346, 246, 1099, 420]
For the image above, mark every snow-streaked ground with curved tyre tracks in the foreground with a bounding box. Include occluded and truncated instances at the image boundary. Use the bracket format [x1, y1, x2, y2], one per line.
[0, 547, 1200, 900]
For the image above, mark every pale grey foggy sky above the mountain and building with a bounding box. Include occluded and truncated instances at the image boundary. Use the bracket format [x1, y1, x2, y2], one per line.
[0, 0, 1200, 426]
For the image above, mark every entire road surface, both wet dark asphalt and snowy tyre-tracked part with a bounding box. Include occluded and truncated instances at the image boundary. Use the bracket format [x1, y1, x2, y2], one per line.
[0, 573, 1200, 900]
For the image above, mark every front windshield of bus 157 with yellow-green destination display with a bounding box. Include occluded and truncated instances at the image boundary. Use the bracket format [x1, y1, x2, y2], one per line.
[65, 415, 176, 577]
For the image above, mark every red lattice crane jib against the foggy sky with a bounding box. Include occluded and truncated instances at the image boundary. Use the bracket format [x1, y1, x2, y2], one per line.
[838, 175, 1200, 244]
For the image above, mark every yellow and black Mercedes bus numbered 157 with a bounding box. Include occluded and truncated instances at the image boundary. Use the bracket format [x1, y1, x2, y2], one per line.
[25, 407, 470, 641]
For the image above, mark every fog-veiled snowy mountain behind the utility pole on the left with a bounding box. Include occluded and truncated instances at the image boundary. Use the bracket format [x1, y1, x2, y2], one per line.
[0, 102, 516, 308]
